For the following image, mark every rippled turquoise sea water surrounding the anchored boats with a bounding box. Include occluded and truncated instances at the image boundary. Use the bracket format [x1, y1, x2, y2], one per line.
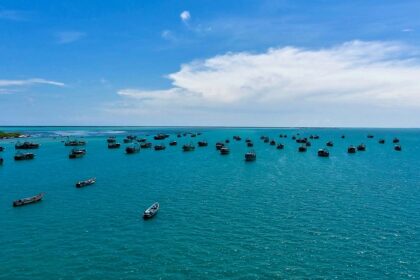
[0, 127, 420, 279]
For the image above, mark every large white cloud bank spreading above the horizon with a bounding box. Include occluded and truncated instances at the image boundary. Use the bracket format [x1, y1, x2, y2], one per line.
[113, 41, 420, 125]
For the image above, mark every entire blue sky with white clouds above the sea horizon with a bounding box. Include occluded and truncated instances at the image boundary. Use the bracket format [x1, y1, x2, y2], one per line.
[0, 0, 420, 127]
